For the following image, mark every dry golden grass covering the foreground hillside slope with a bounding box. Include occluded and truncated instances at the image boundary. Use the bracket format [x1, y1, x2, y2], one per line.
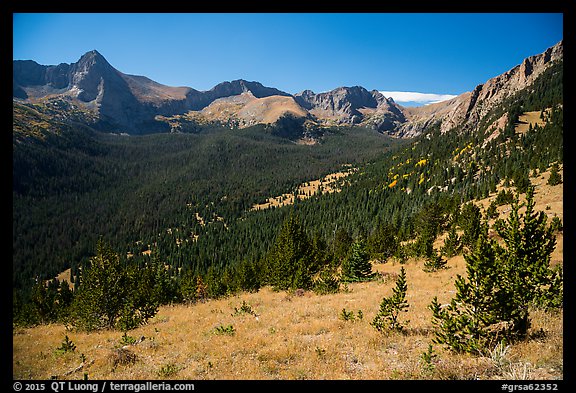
[12, 167, 563, 380]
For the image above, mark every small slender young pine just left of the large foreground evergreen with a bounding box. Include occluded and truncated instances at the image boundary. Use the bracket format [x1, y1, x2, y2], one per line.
[370, 267, 410, 332]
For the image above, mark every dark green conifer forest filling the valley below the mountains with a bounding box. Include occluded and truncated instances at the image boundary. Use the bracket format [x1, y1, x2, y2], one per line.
[13, 59, 563, 344]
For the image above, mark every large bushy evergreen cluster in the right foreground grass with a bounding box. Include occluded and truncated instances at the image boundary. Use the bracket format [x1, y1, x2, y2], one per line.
[430, 186, 563, 354]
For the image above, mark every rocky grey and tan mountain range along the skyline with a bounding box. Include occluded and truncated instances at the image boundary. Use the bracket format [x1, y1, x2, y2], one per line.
[13, 41, 563, 137]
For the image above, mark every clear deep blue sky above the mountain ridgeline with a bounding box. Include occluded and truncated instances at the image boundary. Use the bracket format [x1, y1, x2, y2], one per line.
[13, 13, 563, 105]
